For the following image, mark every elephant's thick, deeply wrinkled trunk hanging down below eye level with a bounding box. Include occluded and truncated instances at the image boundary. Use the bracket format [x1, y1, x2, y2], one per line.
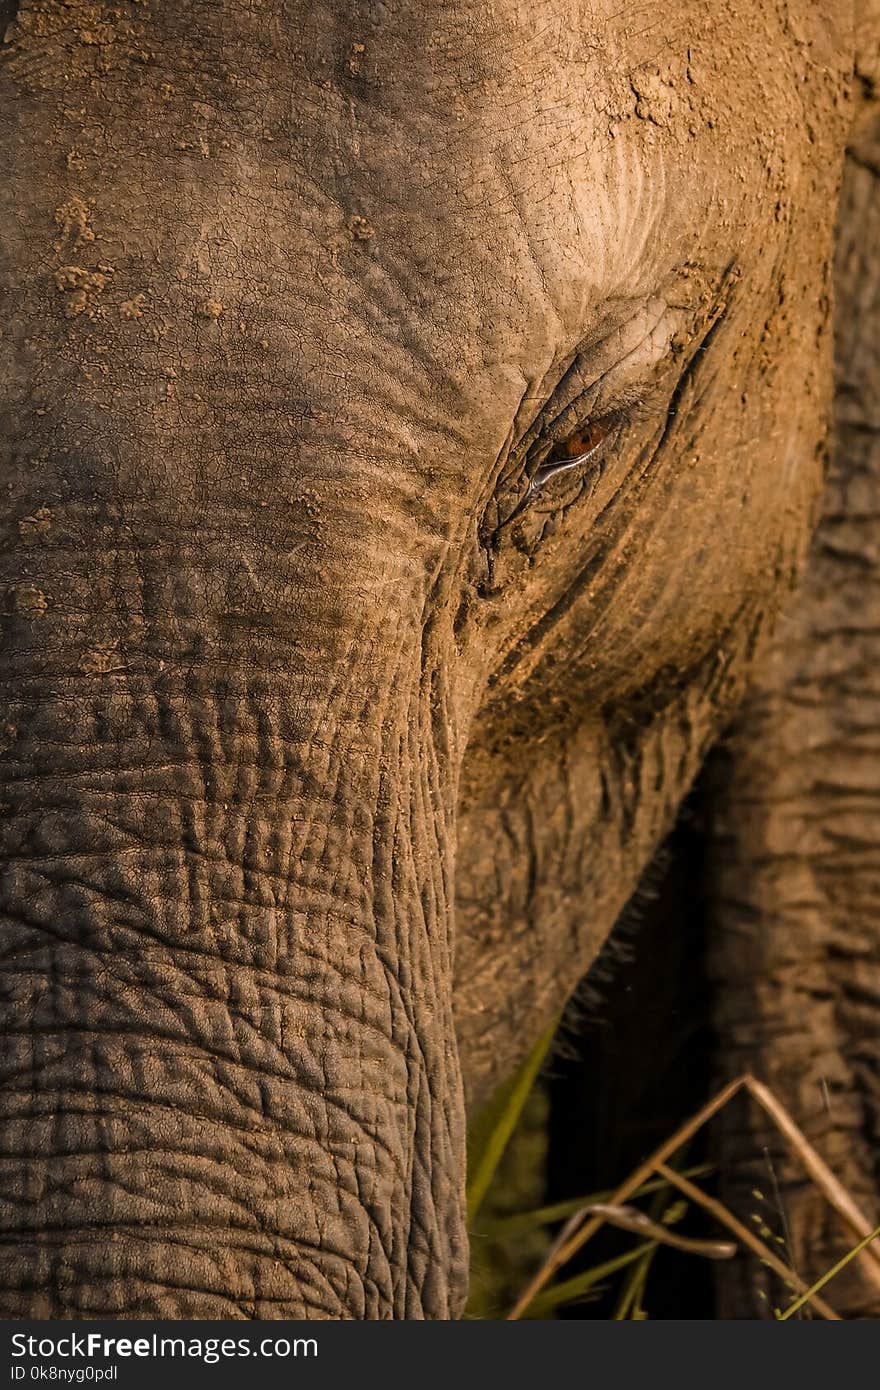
[0, 518, 467, 1318]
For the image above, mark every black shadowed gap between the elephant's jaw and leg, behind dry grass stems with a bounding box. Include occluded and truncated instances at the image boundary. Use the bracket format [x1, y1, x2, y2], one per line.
[546, 787, 717, 1319]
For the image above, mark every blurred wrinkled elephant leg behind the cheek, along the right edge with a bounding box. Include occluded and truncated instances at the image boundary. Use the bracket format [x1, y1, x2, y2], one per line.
[710, 95, 880, 1318]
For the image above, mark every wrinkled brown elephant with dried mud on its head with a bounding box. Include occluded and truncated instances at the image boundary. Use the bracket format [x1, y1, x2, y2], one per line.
[0, 0, 880, 1319]
